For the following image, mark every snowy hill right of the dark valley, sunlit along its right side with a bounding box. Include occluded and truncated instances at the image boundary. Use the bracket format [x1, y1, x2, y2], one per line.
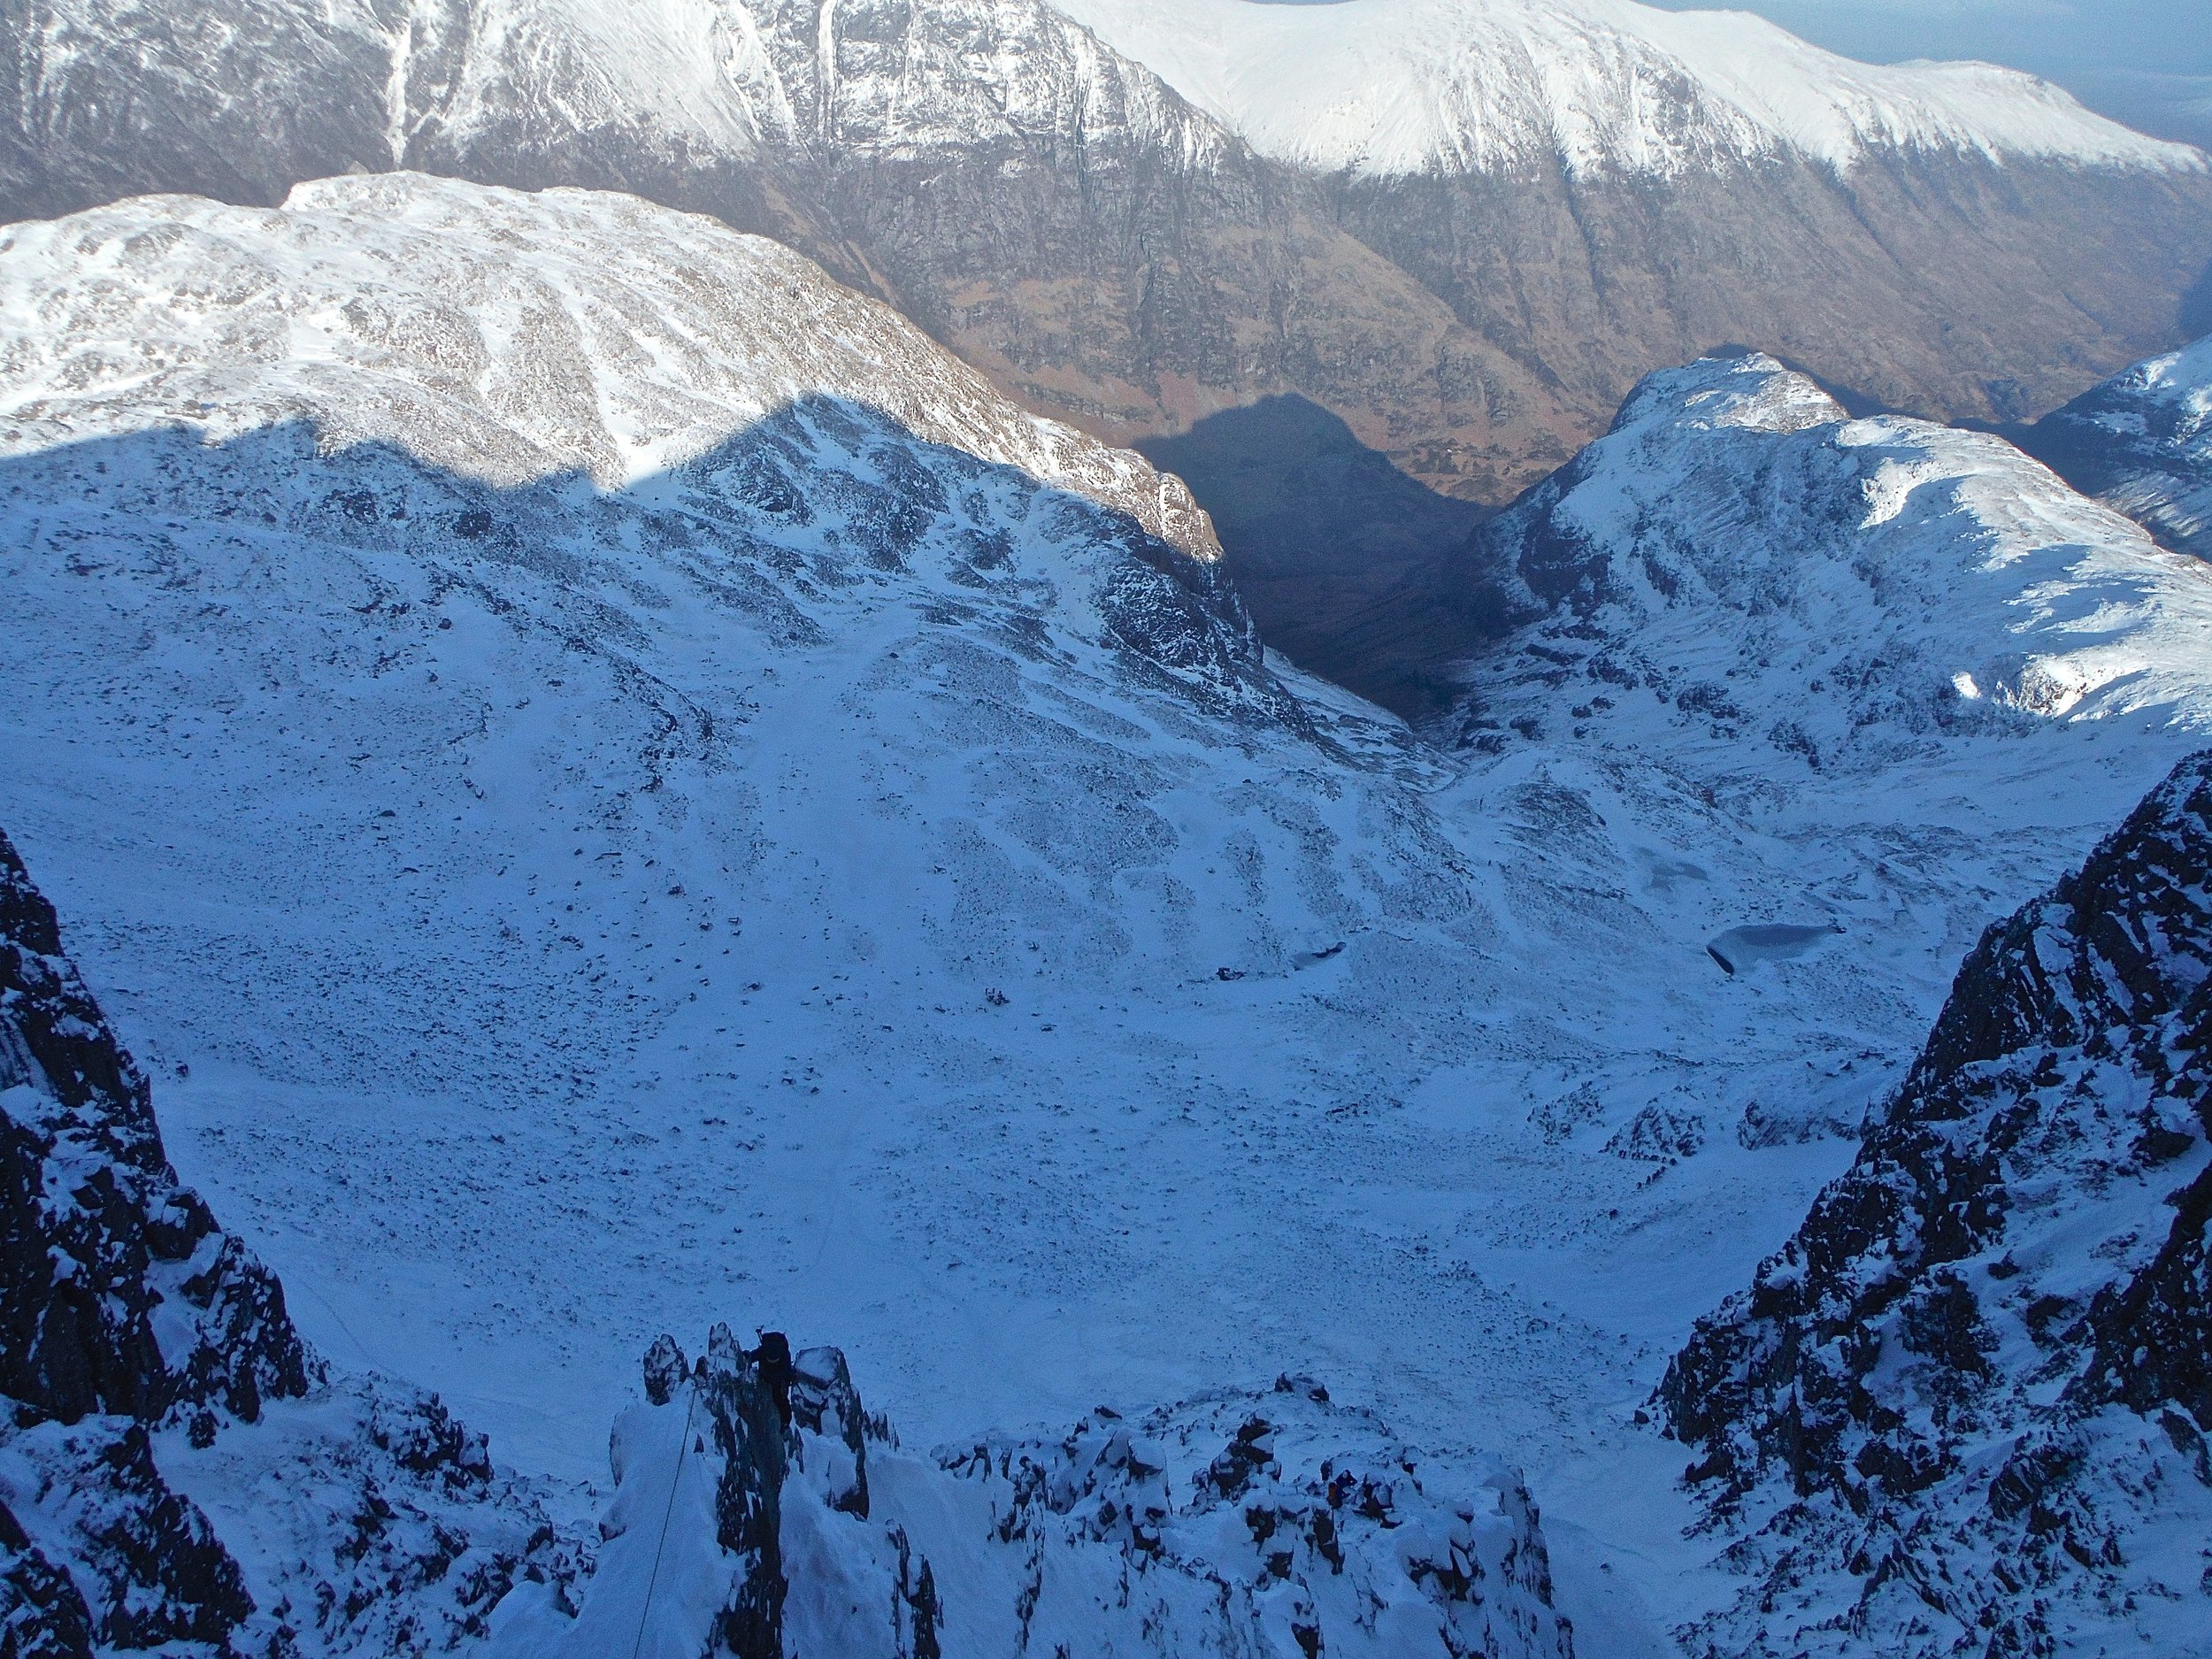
[1463, 357, 2212, 770]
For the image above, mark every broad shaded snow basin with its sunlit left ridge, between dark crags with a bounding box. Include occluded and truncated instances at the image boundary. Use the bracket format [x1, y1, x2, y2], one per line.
[0, 175, 2208, 1653]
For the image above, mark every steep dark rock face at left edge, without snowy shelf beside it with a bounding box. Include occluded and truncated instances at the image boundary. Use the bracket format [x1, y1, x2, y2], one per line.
[0, 836, 310, 1653]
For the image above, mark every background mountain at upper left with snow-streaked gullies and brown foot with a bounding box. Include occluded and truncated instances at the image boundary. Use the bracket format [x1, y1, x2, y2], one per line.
[0, 0, 1573, 487]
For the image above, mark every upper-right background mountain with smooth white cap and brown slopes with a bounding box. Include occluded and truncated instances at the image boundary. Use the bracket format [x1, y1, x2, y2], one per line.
[1066, 0, 2212, 435]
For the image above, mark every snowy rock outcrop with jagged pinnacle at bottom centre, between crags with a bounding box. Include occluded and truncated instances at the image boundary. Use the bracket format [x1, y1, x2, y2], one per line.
[507, 1327, 1573, 1659]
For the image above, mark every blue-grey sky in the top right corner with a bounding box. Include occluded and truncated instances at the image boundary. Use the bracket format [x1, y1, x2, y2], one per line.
[1283, 0, 2212, 146]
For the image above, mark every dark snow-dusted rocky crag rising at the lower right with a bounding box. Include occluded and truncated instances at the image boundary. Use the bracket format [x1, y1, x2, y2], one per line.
[1659, 755, 2212, 1655]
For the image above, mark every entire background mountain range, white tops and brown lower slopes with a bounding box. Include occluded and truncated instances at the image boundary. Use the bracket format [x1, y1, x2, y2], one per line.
[0, 0, 2212, 708]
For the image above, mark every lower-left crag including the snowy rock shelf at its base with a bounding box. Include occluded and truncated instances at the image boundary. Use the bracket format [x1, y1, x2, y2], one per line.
[0, 836, 565, 1659]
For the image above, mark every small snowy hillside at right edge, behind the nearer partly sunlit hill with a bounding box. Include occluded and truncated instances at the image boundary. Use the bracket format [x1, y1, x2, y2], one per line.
[2020, 339, 2212, 557]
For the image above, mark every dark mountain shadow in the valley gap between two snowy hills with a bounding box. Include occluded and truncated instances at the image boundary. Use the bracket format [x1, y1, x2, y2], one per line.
[1135, 394, 1491, 715]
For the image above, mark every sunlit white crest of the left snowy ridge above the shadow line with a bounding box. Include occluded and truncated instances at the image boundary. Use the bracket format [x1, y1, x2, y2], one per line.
[0, 175, 1219, 560]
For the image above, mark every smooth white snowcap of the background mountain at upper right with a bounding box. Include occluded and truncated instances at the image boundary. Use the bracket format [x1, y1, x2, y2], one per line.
[1060, 0, 2206, 177]
